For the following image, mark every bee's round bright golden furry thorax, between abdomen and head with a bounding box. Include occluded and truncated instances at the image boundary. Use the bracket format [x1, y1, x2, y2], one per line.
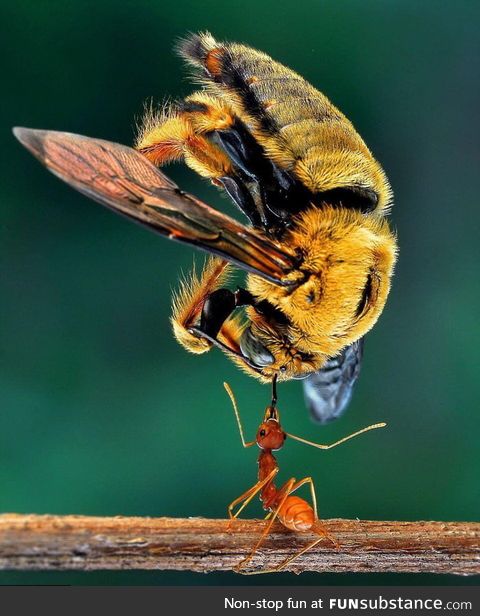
[248, 206, 396, 357]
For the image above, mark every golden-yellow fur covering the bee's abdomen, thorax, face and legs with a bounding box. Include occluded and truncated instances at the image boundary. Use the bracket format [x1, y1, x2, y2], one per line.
[136, 33, 397, 380]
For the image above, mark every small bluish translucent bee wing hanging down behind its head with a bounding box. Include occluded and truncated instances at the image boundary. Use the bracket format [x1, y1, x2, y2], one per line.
[303, 338, 363, 423]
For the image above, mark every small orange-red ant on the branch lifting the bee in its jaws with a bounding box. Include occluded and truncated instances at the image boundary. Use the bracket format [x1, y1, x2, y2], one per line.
[223, 378, 387, 575]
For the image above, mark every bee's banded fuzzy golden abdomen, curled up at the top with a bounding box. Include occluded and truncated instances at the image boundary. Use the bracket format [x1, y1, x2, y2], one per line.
[180, 33, 391, 212]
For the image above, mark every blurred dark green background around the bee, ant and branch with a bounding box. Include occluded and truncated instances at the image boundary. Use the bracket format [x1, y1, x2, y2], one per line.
[0, 0, 480, 584]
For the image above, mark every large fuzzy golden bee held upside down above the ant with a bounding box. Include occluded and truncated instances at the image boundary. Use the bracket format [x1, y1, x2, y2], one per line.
[15, 33, 397, 422]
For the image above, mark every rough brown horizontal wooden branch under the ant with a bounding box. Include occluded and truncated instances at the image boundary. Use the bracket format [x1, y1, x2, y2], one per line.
[0, 514, 480, 575]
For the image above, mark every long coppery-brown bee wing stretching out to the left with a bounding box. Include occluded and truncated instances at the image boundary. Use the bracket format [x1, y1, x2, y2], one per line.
[13, 128, 296, 286]
